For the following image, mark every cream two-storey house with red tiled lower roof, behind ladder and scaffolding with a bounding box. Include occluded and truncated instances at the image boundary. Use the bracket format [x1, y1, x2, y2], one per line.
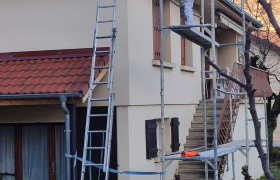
[0, 0, 271, 180]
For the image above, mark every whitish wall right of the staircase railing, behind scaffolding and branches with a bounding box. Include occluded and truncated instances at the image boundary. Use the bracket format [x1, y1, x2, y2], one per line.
[223, 102, 266, 180]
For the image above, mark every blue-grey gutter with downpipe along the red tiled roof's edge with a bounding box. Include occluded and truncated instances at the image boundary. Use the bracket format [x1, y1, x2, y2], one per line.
[0, 93, 82, 180]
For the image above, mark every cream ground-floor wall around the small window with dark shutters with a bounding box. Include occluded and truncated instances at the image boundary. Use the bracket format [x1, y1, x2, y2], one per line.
[117, 105, 196, 180]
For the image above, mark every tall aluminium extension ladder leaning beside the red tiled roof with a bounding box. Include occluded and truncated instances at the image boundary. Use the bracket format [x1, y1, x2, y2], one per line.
[81, 0, 117, 180]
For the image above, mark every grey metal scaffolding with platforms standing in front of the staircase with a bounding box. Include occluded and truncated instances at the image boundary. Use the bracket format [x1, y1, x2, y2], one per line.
[158, 0, 269, 180]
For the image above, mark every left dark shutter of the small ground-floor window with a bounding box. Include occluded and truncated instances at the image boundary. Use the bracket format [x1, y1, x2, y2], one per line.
[145, 119, 158, 159]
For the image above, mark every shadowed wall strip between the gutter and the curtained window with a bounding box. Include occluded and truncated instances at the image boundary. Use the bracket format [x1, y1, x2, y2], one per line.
[0, 105, 65, 123]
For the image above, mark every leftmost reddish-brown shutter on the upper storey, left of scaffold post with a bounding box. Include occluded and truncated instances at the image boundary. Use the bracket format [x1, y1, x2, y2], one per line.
[153, 0, 160, 60]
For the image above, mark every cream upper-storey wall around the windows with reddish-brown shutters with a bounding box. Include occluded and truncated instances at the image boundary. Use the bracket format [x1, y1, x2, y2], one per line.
[128, 0, 201, 105]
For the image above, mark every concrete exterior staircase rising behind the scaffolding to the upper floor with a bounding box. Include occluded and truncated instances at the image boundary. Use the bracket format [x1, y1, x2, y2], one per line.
[178, 99, 223, 180]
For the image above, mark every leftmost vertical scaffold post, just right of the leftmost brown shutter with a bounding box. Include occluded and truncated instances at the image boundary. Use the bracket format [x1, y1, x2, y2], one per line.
[159, 0, 165, 180]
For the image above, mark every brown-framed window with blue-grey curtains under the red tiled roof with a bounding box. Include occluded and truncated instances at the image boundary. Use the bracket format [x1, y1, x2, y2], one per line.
[0, 124, 65, 180]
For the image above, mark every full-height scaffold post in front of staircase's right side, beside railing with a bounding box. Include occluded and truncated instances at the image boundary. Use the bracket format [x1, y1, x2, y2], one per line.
[211, 0, 218, 180]
